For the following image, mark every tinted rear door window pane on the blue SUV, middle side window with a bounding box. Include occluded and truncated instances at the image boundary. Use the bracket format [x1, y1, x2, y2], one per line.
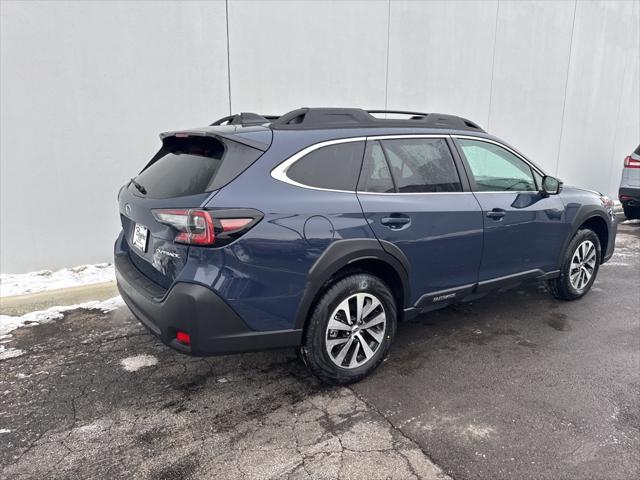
[381, 138, 462, 193]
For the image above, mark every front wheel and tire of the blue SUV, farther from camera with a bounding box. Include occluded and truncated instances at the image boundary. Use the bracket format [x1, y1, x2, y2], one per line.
[547, 229, 602, 300]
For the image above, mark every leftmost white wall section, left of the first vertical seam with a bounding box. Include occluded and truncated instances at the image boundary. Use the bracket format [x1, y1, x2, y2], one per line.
[0, 2, 229, 273]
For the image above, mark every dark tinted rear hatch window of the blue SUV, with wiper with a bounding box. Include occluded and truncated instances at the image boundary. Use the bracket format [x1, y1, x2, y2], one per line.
[136, 137, 262, 198]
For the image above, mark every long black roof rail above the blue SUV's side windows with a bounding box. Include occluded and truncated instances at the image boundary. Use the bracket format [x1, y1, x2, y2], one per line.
[271, 108, 484, 132]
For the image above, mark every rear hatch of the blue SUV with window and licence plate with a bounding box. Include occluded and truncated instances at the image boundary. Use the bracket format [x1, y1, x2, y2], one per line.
[118, 131, 263, 288]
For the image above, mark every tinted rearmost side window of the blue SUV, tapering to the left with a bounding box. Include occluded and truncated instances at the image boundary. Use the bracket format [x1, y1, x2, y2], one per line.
[287, 141, 364, 192]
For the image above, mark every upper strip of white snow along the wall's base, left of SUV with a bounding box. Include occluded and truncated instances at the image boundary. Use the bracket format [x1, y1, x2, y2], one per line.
[0, 263, 115, 297]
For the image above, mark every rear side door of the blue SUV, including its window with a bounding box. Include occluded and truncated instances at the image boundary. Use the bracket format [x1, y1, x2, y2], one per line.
[358, 135, 483, 308]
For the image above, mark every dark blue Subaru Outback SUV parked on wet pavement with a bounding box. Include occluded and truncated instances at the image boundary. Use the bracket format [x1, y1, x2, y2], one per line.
[115, 108, 616, 384]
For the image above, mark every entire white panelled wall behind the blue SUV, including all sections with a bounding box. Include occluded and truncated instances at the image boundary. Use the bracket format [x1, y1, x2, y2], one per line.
[0, 0, 640, 273]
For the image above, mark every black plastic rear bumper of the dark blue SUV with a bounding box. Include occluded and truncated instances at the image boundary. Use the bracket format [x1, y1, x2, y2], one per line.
[114, 248, 302, 356]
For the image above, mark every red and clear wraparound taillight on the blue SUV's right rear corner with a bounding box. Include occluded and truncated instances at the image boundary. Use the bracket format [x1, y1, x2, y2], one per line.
[153, 209, 262, 246]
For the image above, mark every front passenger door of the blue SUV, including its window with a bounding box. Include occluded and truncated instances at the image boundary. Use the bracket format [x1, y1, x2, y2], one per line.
[455, 136, 569, 286]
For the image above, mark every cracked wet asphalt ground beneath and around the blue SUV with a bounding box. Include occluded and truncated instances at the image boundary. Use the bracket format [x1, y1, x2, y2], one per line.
[0, 219, 640, 479]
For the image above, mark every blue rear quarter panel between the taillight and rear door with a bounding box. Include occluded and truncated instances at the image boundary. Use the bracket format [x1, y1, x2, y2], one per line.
[181, 132, 374, 330]
